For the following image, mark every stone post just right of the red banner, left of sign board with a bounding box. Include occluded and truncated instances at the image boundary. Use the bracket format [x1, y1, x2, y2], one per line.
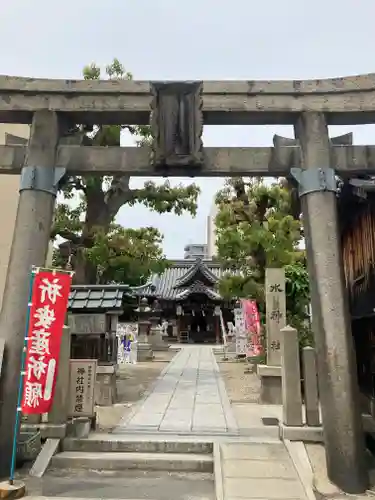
[48, 326, 71, 438]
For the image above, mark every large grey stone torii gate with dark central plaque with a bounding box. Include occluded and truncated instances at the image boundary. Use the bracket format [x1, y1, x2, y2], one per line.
[0, 75, 375, 493]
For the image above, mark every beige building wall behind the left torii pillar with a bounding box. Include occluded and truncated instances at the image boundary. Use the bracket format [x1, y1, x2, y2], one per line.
[0, 123, 53, 310]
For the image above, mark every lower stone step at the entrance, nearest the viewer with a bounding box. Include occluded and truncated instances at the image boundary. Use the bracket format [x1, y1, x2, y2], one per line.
[51, 451, 213, 472]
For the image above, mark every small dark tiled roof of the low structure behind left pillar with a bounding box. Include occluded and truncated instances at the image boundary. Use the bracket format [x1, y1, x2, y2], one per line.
[68, 285, 130, 312]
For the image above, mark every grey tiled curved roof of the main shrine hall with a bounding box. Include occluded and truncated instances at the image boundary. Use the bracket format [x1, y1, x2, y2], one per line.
[132, 259, 226, 300]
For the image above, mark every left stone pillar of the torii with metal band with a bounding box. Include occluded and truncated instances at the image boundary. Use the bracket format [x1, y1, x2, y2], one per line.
[0, 111, 62, 477]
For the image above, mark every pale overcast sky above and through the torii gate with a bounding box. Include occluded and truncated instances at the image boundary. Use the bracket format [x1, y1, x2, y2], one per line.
[0, 0, 375, 258]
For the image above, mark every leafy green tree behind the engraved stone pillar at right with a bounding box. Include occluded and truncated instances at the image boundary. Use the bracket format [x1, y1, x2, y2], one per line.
[216, 178, 312, 345]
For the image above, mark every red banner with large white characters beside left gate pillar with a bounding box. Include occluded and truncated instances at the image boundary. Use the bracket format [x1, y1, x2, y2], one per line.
[21, 271, 72, 415]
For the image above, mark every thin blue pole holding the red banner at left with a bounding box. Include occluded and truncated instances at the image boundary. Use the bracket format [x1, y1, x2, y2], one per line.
[9, 266, 39, 484]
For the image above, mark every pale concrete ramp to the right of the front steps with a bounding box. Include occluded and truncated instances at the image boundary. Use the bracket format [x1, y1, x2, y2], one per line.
[220, 443, 307, 500]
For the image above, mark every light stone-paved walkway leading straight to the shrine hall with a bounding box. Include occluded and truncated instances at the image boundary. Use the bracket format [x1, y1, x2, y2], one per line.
[115, 345, 237, 434]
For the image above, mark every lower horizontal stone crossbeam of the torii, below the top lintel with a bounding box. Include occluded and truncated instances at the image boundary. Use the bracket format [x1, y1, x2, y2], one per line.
[0, 145, 375, 179]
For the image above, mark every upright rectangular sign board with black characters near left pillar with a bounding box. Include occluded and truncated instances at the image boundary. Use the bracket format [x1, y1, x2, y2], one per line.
[69, 359, 97, 417]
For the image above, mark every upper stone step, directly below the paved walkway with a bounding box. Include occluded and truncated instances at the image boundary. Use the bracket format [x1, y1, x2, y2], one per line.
[62, 435, 213, 454]
